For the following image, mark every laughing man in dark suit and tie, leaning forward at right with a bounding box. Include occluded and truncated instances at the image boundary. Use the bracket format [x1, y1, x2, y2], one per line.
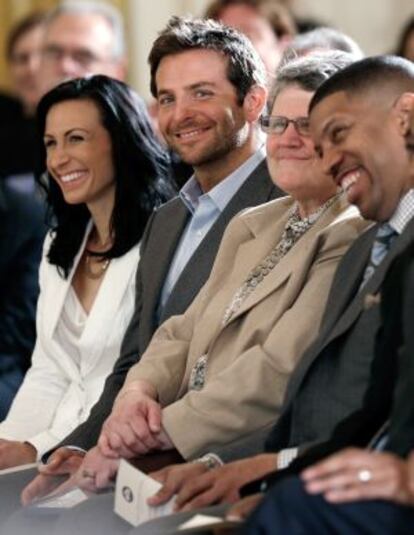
[140, 57, 414, 507]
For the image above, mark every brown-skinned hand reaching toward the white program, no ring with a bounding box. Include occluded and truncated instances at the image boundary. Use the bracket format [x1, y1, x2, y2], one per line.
[152, 454, 276, 511]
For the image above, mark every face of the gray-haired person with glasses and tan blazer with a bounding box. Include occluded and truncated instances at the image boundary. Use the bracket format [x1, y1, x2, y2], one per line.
[266, 86, 336, 208]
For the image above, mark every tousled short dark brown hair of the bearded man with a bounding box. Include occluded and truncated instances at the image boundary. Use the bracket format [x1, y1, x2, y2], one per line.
[148, 17, 266, 104]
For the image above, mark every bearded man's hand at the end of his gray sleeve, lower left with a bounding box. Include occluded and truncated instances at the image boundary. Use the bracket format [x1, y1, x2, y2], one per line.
[21, 448, 84, 505]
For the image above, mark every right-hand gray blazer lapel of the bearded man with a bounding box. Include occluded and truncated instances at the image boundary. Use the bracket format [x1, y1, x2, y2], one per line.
[162, 161, 281, 318]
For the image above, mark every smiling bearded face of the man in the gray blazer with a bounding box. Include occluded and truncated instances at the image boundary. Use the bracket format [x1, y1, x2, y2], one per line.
[156, 49, 265, 188]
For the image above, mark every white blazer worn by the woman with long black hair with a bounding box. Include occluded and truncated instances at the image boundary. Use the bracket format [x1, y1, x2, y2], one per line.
[0, 226, 139, 457]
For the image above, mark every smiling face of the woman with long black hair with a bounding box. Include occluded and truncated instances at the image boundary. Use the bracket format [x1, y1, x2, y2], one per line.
[44, 100, 115, 211]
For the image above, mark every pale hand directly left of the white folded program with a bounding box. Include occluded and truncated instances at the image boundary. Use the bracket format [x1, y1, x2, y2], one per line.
[75, 446, 119, 492]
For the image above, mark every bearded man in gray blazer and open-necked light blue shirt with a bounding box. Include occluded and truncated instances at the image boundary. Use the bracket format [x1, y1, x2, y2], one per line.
[0, 15, 282, 518]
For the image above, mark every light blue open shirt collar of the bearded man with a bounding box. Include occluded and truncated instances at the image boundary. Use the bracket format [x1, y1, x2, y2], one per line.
[179, 145, 266, 214]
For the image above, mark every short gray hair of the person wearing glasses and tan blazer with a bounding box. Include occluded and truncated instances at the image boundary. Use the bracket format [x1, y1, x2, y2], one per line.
[268, 50, 356, 111]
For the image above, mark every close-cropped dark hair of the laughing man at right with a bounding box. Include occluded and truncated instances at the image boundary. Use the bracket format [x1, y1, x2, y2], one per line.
[309, 56, 414, 112]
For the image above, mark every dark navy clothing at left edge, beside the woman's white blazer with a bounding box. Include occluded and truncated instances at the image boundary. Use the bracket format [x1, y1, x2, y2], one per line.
[0, 180, 46, 420]
